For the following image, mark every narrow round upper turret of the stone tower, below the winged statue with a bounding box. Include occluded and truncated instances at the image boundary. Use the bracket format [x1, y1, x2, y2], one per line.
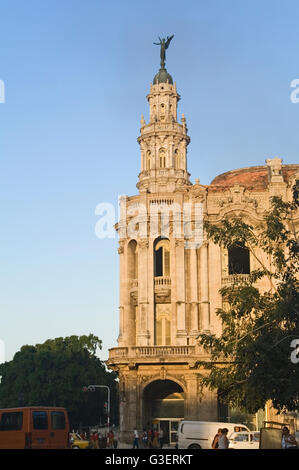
[137, 69, 190, 194]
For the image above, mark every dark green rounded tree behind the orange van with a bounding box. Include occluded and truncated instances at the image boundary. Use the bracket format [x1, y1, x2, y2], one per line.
[0, 334, 118, 427]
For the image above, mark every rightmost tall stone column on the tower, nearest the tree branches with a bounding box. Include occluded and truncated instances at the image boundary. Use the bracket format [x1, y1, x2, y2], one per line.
[200, 241, 210, 331]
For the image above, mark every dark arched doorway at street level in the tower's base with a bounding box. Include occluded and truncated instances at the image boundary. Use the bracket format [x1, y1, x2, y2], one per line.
[143, 380, 185, 444]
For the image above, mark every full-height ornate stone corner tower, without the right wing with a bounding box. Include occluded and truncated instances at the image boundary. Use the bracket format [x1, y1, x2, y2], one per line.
[108, 38, 217, 443]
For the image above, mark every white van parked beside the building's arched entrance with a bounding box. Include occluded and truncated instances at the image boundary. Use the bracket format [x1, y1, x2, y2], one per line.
[177, 421, 250, 449]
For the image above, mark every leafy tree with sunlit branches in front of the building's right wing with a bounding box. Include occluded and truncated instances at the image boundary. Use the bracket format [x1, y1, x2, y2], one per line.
[199, 181, 299, 413]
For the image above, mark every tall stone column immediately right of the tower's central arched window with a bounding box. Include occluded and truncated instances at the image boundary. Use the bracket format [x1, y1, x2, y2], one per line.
[175, 239, 187, 346]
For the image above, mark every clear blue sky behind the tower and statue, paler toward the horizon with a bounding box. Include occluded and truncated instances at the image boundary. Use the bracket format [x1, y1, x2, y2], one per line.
[0, 0, 299, 360]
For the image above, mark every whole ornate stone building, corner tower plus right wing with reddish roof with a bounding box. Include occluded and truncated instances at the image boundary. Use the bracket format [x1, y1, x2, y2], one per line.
[108, 62, 299, 443]
